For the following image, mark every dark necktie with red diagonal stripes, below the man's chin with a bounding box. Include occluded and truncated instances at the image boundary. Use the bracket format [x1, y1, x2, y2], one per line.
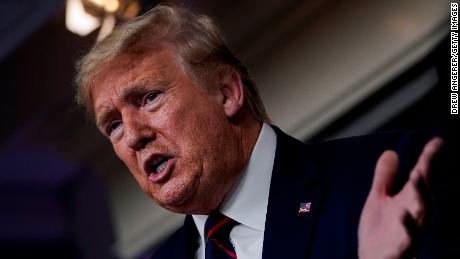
[204, 210, 239, 259]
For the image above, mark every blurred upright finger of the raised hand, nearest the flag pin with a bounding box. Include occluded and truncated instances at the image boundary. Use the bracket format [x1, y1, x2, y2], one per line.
[371, 150, 399, 195]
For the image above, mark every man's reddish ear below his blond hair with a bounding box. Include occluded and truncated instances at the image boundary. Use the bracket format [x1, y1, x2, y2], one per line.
[219, 69, 244, 118]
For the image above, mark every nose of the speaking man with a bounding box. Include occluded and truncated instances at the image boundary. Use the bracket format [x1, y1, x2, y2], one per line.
[123, 114, 155, 151]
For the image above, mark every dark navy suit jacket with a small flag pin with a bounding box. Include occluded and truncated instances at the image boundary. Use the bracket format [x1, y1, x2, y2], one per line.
[152, 127, 454, 259]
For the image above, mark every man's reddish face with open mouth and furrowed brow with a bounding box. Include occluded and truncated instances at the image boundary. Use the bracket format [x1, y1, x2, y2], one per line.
[90, 48, 244, 214]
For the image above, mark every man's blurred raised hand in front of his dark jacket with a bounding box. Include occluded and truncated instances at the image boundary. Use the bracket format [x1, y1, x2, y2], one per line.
[358, 138, 442, 259]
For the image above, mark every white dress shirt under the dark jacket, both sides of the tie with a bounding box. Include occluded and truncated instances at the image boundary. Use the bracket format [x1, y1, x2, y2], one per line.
[193, 123, 276, 259]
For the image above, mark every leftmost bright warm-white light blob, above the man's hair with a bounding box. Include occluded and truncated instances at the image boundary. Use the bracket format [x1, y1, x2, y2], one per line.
[65, 0, 101, 36]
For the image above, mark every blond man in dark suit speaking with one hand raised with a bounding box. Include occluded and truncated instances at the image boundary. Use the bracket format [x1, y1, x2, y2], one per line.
[77, 6, 441, 259]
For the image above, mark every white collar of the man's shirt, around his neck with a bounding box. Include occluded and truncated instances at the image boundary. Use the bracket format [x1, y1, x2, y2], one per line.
[193, 123, 276, 236]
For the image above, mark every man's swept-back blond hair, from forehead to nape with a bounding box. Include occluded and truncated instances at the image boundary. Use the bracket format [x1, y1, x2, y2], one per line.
[75, 5, 270, 122]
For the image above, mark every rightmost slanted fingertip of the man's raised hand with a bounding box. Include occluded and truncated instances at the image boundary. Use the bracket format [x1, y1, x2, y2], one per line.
[411, 137, 443, 184]
